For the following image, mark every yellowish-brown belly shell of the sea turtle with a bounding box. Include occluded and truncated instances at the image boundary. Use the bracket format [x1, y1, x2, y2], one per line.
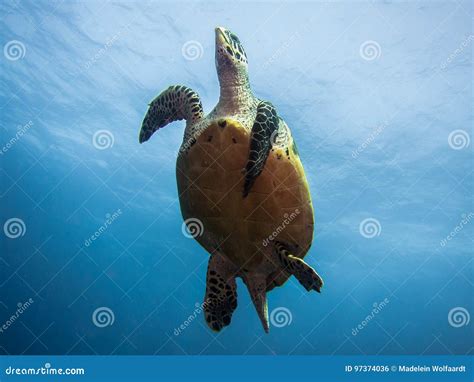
[176, 119, 314, 285]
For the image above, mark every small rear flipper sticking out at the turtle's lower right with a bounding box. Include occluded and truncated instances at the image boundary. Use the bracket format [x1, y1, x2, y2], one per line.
[275, 241, 323, 293]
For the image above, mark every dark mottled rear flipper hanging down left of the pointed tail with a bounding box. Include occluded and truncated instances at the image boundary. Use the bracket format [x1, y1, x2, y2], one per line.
[204, 253, 237, 332]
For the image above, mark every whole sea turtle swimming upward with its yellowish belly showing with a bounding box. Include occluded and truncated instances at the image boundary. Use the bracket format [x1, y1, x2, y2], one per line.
[139, 27, 323, 332]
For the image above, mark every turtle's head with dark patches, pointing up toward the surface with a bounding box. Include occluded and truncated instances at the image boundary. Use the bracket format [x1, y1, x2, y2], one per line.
[216, 27, 248, 82]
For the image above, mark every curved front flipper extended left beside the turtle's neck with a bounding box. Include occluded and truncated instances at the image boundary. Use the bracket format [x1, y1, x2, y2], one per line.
[139, 85, 203, 143]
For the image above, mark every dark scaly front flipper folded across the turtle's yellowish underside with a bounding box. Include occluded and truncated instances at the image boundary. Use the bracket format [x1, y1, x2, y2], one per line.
[244, 101, 279, 198]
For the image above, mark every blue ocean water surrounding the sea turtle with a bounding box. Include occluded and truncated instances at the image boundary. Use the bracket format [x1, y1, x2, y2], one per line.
[0, 1, 474, 354]
